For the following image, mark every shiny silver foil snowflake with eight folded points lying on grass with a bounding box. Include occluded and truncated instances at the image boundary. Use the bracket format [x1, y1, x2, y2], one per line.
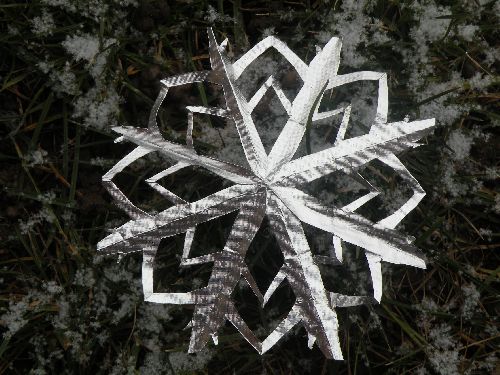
[97, 29, 434, 359]
